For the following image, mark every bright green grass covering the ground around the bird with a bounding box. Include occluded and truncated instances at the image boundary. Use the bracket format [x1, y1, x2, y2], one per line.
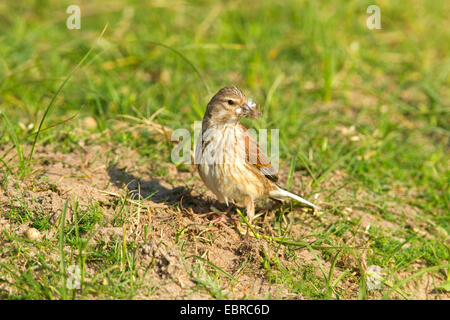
[0, 0, 450, 299]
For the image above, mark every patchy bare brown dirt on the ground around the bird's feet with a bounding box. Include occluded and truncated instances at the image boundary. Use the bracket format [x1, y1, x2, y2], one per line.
[0, 145, 448, 299]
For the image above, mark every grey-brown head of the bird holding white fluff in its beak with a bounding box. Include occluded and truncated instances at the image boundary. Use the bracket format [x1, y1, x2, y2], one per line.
[205, 87, 261, 124]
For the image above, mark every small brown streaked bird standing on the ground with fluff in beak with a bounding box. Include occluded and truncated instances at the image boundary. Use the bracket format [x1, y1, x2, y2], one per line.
[194, 86, 320, 223]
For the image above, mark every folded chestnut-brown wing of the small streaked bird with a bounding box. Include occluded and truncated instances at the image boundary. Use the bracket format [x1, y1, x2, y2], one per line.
[241, 125, 278, 183]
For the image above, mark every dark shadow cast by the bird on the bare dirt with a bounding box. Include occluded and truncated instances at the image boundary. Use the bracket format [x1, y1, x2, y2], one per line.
[107, 164, 217, 214]
